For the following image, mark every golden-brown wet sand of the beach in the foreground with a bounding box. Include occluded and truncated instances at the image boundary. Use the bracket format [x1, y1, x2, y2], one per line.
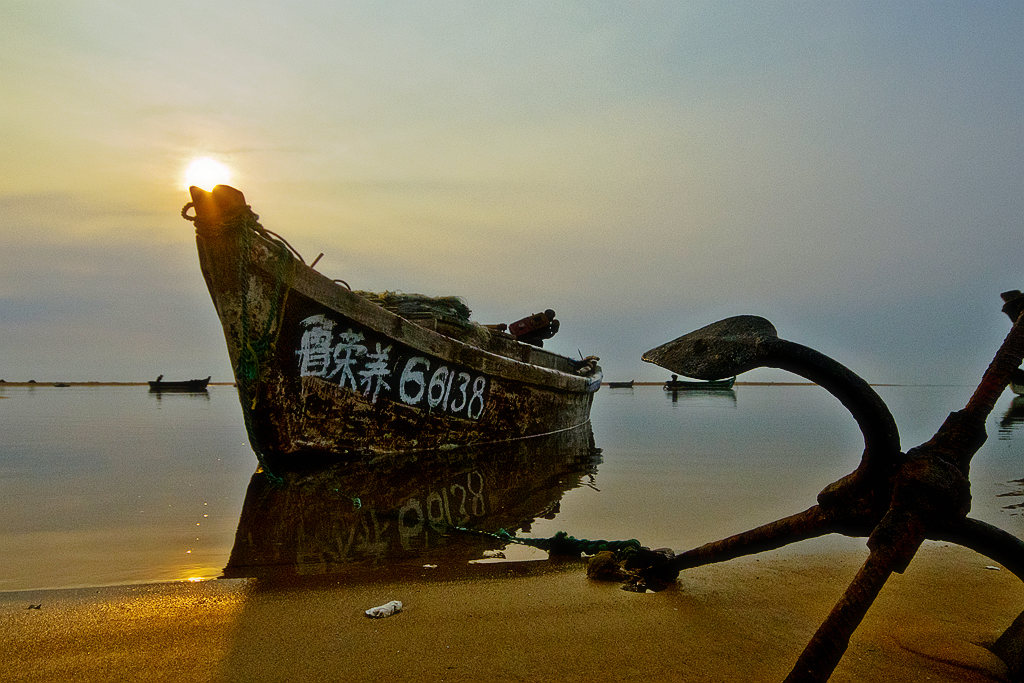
[0, 544, 1024, 681]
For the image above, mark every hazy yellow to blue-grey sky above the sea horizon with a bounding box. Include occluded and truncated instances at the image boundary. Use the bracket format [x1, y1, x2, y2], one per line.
[0, 0, 1024, 385]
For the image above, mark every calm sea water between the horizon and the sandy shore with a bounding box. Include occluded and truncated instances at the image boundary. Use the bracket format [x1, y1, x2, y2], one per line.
[0, 385, 1024, 591]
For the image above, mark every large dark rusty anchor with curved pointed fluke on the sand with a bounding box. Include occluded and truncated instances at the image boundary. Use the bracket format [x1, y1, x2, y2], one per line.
[642, 290, 1024, 681]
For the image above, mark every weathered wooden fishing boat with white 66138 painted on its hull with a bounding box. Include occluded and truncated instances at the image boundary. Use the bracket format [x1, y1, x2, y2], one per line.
[182, 185, 601, 469]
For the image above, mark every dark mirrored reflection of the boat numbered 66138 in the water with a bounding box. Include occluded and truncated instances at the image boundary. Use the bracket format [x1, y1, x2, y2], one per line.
[224, 425, 600, 579]
